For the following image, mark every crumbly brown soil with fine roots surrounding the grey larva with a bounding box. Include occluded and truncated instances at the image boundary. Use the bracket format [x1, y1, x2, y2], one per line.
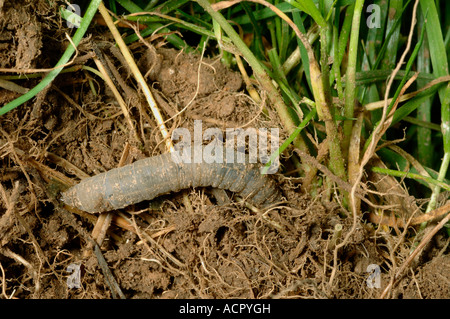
[0, 0, 450, 299]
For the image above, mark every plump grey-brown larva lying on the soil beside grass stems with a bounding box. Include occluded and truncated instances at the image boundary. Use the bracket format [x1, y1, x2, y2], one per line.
[62, 153, 280, 213]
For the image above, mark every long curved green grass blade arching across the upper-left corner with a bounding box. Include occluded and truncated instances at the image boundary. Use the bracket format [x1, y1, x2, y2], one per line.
[0, 0, 101, 115]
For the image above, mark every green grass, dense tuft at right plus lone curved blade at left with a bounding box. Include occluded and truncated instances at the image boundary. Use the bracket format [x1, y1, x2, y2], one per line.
[0, 0, 450, 220]
